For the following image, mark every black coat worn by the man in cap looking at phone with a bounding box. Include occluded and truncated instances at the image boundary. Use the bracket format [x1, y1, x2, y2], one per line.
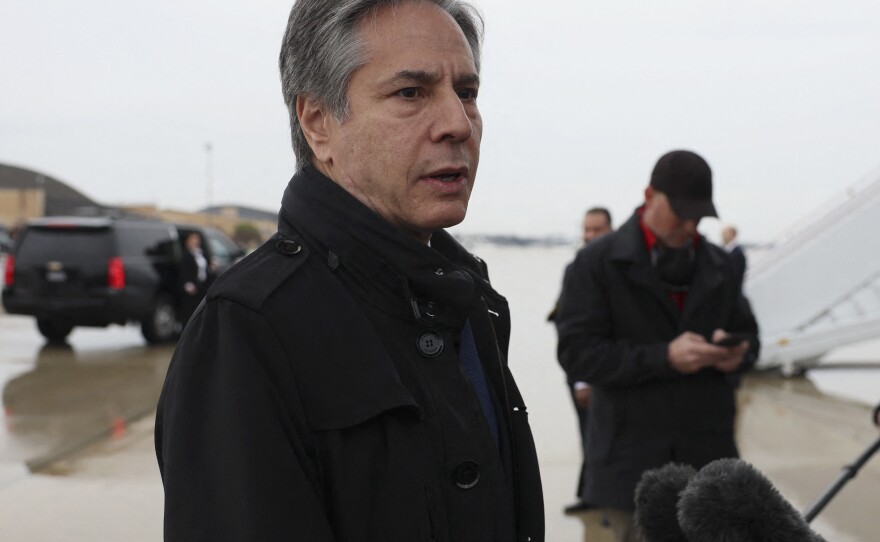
[556, 211, 758, 509]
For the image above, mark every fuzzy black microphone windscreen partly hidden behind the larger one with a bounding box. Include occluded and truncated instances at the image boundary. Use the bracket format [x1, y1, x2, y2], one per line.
[635, 463, 697, 542]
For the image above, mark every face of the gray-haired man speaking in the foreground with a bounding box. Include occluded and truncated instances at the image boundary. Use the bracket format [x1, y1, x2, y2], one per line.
[315, 2, 483, 242]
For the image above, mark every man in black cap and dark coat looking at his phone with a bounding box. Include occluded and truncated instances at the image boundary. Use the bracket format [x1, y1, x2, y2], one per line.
[556, 150, 759, 541]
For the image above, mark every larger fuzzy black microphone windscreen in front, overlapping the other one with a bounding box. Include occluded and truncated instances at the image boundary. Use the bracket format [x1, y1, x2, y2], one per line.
[678, 459, 824, 542]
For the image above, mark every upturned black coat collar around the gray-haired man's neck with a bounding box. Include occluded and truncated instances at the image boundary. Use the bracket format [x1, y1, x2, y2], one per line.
[279, 166, 500, 325]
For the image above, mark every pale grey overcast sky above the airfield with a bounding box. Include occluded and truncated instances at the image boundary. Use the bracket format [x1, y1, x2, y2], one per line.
[0, 0, 880, 242]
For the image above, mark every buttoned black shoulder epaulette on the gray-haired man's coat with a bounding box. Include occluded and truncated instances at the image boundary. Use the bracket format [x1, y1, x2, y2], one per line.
[206, 234, 309, 310]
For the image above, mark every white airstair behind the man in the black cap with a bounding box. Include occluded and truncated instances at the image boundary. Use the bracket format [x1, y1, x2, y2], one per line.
[744, 164, 880, 371]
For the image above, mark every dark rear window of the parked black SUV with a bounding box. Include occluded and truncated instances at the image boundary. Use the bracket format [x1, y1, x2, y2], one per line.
[16, 228, 113, 263]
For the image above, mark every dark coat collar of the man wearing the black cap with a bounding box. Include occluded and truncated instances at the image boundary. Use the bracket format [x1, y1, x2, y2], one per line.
[609, 210, 725, 328]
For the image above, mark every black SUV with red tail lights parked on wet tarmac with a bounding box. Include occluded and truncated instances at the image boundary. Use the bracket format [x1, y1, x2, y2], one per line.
[3, 217, 243, 344]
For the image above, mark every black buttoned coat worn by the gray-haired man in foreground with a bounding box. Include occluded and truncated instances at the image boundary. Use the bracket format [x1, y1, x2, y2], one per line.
[156, 168, 544, 542]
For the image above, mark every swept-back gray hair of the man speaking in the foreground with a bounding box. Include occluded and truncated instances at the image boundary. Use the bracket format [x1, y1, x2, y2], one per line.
[279, 0, 483, 171]
